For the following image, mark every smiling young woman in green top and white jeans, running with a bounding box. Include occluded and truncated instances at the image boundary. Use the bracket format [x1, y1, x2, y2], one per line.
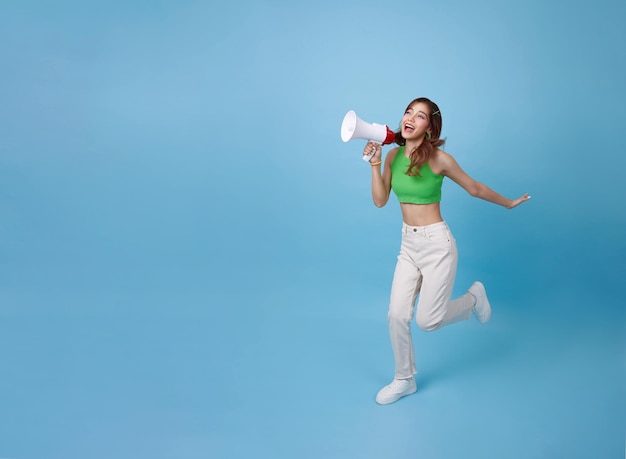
[363, 98, 530, 405]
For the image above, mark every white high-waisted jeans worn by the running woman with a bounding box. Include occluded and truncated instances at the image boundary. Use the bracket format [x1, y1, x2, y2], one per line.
[388, 222, 475, 378]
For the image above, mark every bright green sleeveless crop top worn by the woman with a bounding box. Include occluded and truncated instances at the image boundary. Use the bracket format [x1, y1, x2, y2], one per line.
[391, 147, 443, 204]
